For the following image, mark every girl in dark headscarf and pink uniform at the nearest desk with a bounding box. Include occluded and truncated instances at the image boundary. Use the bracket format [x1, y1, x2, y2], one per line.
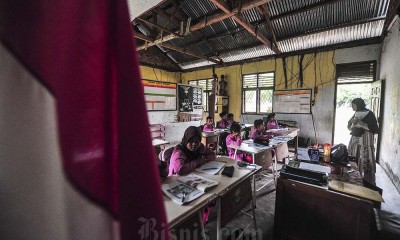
[168, 126, 216, 176]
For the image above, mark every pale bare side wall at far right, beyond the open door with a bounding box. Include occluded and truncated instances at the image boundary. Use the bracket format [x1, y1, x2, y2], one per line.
[379, 18, 400, 191]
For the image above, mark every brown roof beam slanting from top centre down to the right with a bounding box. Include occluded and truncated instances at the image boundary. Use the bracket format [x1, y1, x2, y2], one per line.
[210, 0, 281, 54]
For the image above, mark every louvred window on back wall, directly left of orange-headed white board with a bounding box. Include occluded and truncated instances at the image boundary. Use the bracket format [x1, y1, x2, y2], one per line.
[242, 72, 274, 114]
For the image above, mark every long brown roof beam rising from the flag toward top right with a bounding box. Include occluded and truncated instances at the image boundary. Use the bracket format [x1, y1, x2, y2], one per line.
[136, 0, 272, 51]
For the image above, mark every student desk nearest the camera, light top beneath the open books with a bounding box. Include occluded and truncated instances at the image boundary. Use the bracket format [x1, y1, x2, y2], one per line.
[164, 157, 261, 239]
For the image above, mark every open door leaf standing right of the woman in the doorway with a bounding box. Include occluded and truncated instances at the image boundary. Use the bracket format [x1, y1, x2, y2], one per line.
[371, 80, 385, 163]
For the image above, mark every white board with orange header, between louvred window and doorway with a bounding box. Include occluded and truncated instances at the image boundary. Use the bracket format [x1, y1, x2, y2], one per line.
[272, 89, 312, 114]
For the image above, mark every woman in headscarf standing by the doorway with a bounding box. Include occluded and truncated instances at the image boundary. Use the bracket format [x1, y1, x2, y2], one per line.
[347, 98, 379, 185]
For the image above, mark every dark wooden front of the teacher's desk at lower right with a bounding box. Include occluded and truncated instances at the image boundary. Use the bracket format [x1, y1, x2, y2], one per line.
[274, 166, 373, 240]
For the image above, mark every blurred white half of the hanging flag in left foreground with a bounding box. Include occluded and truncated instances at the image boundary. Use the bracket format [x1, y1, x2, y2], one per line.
[0, 45, 112, 240]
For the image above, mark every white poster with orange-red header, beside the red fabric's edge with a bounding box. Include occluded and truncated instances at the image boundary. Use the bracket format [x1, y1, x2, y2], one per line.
[142, 80, 176, 111]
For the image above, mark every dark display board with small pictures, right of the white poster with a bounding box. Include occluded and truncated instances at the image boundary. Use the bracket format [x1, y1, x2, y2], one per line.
[178, 84, 203, 112]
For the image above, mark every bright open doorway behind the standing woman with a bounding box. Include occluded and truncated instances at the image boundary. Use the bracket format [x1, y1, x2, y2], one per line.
[333, 83, 371, 145]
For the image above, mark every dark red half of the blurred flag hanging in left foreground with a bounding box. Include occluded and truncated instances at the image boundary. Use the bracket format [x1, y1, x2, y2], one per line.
[0, 0, 166, 239]
